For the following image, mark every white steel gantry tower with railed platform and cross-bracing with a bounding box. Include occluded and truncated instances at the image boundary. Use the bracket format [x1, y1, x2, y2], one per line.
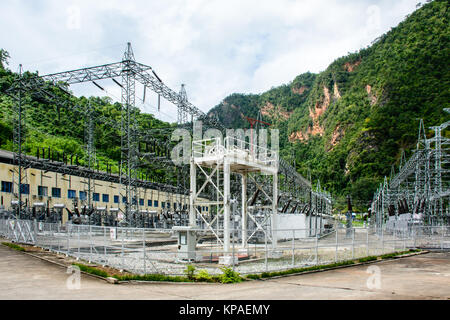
[189, 137, 279, 254]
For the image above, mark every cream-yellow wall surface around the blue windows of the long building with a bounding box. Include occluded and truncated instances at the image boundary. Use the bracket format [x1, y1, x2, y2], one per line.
[0, 163, 209, 213]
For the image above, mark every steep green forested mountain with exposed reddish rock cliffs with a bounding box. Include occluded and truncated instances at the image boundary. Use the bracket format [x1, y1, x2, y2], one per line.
[209, 1, 450, 210]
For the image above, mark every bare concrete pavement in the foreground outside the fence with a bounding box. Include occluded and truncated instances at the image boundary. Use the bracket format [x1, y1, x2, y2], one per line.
[0, 245, 450, 300]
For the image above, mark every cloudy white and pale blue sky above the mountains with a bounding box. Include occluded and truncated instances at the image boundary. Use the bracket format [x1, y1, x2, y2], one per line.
[0, 0, 419, 122]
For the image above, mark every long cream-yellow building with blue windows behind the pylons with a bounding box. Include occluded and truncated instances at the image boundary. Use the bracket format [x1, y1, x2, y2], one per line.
[0, 150, 209, 219]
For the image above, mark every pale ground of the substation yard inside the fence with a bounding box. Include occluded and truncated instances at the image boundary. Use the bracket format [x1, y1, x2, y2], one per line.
[30, 229, 413, 275]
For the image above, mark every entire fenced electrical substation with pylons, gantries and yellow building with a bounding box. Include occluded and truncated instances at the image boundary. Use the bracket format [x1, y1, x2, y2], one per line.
[0, 43, 449, 274]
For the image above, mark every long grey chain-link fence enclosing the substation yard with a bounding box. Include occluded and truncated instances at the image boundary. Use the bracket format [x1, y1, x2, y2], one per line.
[0, 219, 450, 275]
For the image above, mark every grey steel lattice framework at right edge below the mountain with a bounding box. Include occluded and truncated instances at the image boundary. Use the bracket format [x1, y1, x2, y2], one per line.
[371, 113, 450, 230]
